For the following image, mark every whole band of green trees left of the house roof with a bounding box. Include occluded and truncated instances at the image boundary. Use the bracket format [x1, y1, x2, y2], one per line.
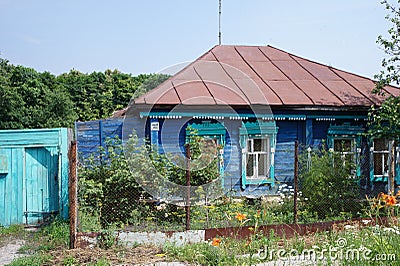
[0, 58, 169, 129]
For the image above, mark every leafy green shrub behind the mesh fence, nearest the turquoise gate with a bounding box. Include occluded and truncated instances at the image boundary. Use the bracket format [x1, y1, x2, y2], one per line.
[78, 138, 150, 228]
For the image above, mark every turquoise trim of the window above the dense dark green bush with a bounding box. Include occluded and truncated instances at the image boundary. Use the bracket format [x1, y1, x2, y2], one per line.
[327, 123, 365, 177]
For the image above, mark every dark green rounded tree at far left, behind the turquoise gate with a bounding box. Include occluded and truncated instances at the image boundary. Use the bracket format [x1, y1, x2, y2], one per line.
[0, 59, 76, 129]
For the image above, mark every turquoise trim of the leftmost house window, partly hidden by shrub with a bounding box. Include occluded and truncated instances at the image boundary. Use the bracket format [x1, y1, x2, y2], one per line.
[185, 121, 226, 186]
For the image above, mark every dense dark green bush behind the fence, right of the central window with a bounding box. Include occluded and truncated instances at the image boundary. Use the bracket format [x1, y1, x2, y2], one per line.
[300, 149, 362, 218]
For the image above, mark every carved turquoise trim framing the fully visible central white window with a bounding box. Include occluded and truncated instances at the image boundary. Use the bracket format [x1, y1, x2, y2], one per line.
[239, 121, 278, 189]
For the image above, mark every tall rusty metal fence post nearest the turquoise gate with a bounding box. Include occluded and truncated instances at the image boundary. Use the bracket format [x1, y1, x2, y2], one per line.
[68, 141, 78, 249]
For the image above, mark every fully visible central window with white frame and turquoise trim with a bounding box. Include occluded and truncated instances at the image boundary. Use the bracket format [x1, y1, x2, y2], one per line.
[239, 122, 277, 189]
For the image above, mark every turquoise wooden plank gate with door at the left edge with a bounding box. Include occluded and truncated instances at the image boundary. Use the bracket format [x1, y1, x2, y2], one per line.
[0, 128, 72, 226]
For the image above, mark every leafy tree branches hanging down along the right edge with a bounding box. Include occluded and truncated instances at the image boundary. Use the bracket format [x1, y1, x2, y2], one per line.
[369, 0, 400, 139]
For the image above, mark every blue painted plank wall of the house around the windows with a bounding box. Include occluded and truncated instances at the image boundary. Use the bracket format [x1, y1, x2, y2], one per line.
[76, 112, 400, 197]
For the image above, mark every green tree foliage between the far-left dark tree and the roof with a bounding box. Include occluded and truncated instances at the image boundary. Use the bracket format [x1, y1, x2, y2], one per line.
[57, 70, 165, 121]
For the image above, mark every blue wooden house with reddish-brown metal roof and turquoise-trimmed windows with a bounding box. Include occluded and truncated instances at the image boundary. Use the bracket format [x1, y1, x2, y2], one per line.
[93, 45, 400, 195]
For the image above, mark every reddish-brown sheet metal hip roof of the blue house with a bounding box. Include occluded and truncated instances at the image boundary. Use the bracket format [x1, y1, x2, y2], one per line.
[135, 45, 400, 107]
